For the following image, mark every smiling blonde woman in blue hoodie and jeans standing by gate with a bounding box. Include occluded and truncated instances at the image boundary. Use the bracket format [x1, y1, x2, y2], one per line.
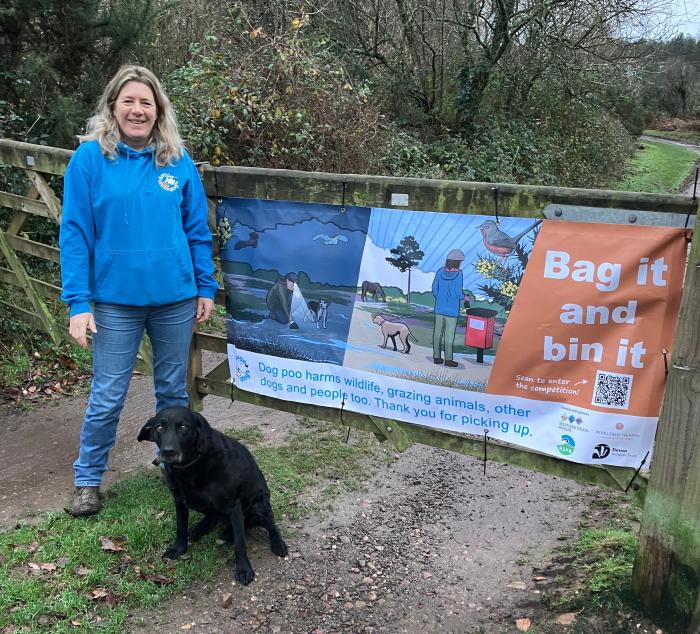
[60, 66, 218, 515]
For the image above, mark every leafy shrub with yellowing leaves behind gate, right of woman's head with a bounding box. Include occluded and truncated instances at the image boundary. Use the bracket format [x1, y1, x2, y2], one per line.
[165, 14, 385, 173]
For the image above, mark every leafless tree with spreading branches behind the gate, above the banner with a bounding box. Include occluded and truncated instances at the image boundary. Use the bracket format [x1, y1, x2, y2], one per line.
[324, 0, 680, 128]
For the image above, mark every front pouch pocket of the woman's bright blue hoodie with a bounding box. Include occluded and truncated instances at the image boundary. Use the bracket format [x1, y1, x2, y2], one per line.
[95, 247, 197, 306]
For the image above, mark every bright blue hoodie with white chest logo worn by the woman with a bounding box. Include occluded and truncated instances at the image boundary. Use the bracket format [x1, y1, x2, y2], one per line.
[59, 141, 219, 316]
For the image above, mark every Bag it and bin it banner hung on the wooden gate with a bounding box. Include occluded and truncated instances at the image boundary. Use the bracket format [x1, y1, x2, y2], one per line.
[217, 198, 687, 467]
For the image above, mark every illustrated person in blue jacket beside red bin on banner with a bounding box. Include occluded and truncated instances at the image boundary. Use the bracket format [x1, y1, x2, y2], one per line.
[432, 249, 471, 368]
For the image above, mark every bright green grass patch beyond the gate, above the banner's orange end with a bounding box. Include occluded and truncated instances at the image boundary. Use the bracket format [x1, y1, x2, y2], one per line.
[613, 141, 698, 194]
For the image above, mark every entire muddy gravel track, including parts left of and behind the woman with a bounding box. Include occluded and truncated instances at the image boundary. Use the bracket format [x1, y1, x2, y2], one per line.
[0, 350, 607, 634]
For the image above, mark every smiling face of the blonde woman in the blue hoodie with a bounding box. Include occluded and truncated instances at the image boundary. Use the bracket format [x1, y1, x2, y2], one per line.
[113, 81, 158, 150]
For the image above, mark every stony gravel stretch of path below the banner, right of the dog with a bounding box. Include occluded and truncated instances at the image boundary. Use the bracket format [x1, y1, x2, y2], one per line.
[129, 447, 596, 634]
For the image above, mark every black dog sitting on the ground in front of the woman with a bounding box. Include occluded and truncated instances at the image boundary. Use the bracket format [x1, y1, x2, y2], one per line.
[138, 407, 287, 585]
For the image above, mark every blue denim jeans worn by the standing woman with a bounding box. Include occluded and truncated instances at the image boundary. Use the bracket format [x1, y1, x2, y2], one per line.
[73, 299, 196, 486]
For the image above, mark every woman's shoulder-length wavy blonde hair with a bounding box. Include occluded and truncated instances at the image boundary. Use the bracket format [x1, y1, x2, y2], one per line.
[78, 64, 183, 167]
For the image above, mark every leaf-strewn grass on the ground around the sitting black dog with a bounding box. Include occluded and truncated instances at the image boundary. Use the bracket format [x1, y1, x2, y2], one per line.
[0, 420, 388, 634]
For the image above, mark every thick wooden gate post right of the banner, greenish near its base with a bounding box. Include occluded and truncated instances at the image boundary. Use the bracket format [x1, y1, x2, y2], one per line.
[632, 218, 700, 634]
